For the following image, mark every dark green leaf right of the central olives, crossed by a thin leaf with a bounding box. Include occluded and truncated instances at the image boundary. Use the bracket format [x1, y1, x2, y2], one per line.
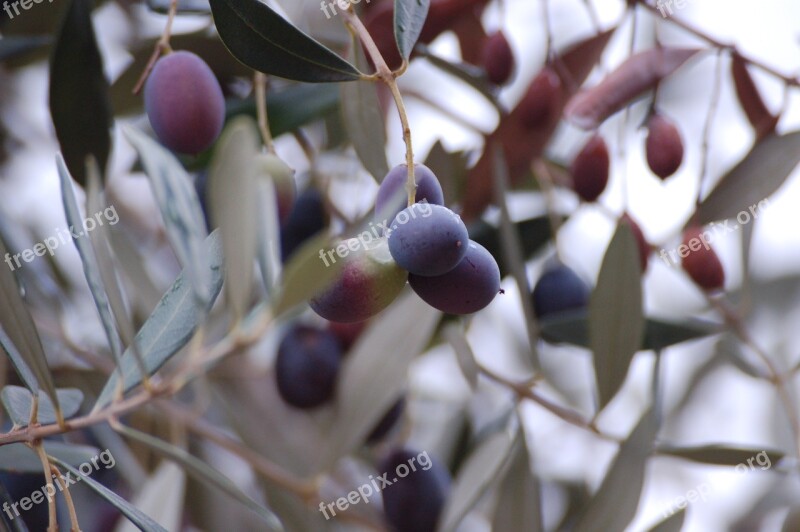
[467, 216, 553, 277]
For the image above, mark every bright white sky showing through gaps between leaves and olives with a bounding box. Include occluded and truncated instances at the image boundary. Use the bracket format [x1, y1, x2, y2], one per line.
[0, 0, 800, 531]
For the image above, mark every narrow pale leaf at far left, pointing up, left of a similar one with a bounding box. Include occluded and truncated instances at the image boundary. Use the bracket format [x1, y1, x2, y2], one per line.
[56, 153, 122, 365]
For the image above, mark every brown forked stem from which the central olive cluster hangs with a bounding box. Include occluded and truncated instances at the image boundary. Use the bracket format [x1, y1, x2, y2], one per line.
[342, 4, 417, 206]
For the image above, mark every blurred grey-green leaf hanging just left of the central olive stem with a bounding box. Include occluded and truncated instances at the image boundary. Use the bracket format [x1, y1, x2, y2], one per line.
[341, 43, 389, 183]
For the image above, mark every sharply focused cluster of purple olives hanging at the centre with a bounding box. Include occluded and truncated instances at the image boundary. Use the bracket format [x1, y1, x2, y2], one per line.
[310, 164, 500, 322]
